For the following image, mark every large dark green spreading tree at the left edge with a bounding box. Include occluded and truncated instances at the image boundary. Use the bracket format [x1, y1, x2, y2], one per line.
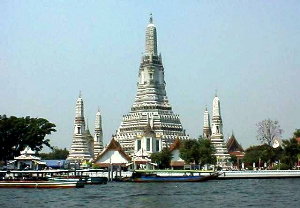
[0, 115, 56, 161]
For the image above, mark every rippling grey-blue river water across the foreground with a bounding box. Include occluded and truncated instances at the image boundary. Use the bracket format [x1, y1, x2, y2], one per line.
[0, 178, 300, 208]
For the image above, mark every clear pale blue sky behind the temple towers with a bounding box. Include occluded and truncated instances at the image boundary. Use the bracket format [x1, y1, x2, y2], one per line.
[0, 0, 300, 148]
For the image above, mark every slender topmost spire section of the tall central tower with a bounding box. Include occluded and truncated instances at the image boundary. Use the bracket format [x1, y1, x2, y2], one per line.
[145, 14, 157, 56]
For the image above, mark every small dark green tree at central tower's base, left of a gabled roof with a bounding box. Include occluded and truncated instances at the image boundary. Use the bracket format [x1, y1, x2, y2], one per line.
[151, 147, 172, 169]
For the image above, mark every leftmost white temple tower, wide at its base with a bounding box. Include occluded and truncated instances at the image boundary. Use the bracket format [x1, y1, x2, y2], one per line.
[67, 94, 93, 162]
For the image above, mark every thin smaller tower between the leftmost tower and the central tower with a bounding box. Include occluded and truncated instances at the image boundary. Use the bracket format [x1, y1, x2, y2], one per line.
[94, 109, 103, 158]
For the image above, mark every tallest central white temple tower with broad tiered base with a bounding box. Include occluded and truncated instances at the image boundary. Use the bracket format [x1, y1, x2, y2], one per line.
[115, 16, 188, 155]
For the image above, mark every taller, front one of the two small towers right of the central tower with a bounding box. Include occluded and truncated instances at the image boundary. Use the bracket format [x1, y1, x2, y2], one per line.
[211, 95, 229, 167]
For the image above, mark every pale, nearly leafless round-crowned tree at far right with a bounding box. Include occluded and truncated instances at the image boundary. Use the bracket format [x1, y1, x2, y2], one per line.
[256, 119, 283, 146]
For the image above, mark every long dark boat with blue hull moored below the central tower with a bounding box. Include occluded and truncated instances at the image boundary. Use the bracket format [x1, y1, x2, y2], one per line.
[127, 172, 219, 183]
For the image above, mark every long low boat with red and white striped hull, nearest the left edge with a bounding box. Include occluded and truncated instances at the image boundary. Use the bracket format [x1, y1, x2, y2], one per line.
[0, 180, 84, 188]
